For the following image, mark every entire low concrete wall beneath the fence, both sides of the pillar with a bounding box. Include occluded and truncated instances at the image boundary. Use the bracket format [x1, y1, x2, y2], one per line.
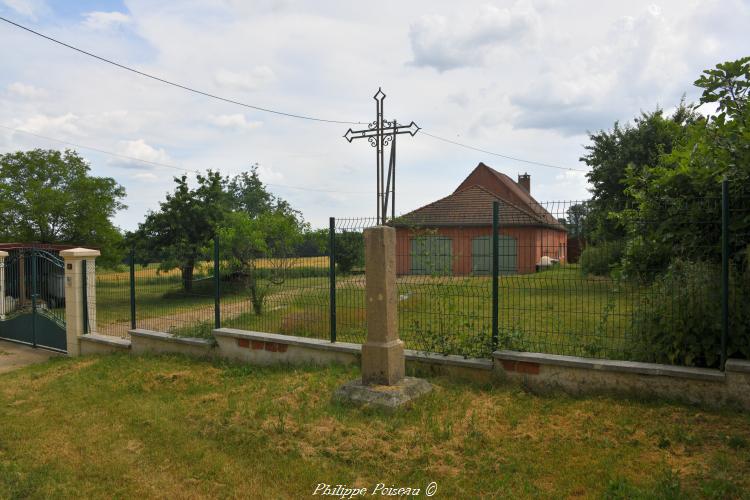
[79, 328, 750, 410]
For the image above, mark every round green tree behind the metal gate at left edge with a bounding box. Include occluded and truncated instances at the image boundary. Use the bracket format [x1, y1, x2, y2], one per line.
[0, 149, 126, 263]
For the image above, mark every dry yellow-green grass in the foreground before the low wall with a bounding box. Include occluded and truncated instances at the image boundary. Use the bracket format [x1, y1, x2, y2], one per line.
[0, 355, 750, 498]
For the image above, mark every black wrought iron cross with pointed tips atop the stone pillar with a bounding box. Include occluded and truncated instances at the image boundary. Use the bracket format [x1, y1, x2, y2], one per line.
[344, 88, 419, 224]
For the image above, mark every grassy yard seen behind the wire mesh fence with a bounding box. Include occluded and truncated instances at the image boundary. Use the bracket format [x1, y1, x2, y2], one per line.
[97, 262, 642, 358]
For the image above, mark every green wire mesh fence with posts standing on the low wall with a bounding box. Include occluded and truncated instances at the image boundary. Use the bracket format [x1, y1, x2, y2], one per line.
[91, 193, 750, 372]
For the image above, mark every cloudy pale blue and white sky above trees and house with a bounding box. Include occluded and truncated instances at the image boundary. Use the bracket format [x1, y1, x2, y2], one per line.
[0, 0, 750, 229]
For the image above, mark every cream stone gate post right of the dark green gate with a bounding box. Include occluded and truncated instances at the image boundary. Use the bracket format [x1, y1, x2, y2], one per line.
[60, 248, 101, 356]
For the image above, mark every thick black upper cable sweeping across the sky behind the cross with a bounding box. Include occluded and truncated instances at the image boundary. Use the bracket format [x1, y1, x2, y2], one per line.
[0, 16, 586, 174]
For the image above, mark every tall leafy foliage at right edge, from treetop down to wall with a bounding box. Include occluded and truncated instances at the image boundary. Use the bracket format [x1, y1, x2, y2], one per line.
[618, 57, 750, 366]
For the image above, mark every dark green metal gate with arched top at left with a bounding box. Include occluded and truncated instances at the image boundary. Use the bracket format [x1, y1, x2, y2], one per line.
[0, 248, 67, 352]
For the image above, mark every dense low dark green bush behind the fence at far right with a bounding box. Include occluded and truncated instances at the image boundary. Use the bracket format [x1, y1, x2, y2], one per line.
[632, 261, 750, 368]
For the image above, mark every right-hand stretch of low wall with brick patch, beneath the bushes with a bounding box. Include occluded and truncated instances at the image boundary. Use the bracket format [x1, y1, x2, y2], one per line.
[493, 351, 750, 409]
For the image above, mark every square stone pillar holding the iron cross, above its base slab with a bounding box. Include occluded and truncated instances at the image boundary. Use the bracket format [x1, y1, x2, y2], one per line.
[362, 226, 406, 385]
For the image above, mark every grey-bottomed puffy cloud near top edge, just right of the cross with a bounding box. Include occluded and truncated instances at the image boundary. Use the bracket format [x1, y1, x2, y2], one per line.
[409, 2, 540, 71]
